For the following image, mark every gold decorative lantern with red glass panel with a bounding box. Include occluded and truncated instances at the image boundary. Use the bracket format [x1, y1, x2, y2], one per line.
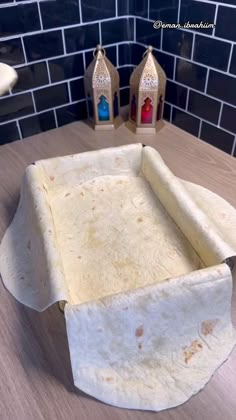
[128, 46, 166, 134]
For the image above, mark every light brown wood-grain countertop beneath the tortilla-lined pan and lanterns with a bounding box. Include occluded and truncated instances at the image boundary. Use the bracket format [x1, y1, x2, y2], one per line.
[0, 122, 236, 420]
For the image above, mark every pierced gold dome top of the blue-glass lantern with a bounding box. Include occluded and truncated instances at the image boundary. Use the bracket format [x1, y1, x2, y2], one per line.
[84, 44, 119, 88]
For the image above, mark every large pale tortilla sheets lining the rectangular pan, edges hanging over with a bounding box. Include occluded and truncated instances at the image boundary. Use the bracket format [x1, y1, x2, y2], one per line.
[0, 144, 236, 411]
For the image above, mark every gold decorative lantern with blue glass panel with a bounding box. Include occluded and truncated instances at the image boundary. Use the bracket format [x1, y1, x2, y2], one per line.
[84, 45, 120, 130]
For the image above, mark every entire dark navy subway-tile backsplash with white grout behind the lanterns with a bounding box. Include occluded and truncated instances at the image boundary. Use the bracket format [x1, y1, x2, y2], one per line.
[0, 0, 236, 156]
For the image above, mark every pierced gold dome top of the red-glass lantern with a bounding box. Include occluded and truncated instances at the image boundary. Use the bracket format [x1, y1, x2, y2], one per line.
[130, 45, 166, 90]
